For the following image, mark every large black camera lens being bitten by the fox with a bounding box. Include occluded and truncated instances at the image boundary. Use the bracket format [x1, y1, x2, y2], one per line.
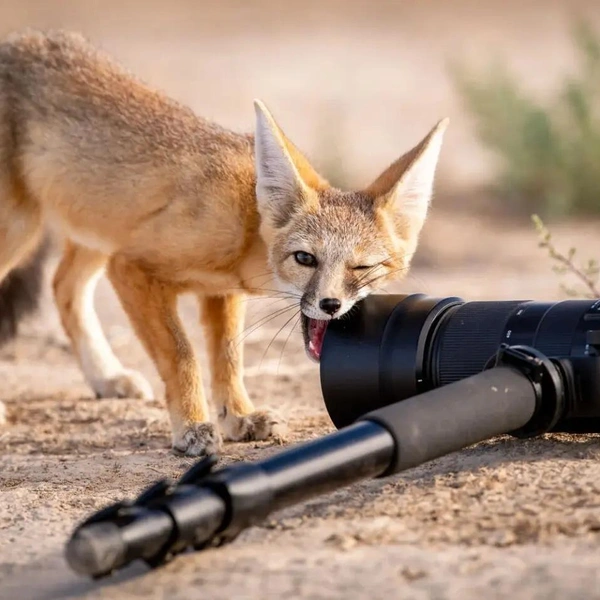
[320, 294, 600, 433]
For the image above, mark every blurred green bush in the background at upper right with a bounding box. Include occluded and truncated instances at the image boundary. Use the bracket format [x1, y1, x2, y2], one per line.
[450, 22, 600, 218]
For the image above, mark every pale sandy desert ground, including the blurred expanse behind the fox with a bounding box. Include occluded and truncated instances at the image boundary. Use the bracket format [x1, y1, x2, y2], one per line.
[0, 0, 600, 600]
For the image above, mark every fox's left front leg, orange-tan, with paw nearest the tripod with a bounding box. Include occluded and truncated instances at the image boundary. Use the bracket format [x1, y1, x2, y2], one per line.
[107, 255, 221, 456]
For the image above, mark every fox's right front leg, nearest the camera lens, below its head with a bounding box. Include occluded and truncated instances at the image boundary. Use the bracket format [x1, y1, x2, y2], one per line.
[200, 294, 287, 442]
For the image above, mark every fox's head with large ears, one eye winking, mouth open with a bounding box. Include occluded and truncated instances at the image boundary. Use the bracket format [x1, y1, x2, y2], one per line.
[254, 100, 448, 361]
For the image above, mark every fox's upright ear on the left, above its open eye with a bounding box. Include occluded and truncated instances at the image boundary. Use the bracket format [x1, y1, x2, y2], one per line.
[254, 100, 328, 226]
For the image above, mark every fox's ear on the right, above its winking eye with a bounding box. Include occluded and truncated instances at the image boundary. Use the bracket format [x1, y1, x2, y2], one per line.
[365, 118, 449, 234]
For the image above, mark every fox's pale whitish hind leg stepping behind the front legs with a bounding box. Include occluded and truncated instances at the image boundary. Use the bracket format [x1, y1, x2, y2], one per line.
[53, 241, 153, 399]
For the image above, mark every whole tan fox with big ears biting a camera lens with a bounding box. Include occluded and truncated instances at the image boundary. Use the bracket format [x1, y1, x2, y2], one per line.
[0, 30, 448, 457]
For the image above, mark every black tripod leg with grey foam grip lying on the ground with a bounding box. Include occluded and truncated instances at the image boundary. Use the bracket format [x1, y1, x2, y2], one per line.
[66, 345, 566, 577]
